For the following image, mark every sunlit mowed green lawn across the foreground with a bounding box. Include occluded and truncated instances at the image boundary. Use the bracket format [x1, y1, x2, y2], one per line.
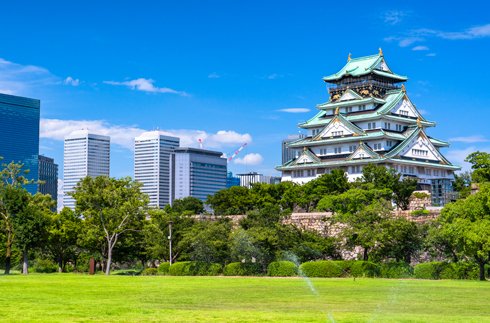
[0, 274, 490, 323]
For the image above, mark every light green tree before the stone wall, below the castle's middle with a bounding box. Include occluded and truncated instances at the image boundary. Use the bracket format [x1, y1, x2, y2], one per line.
[318, 184, 392, 261]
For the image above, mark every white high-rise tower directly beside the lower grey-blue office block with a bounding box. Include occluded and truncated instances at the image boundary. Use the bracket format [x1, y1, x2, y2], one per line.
[134, 130, 180, 209]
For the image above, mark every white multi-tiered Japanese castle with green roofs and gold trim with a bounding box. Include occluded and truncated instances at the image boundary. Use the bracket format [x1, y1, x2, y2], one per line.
[276, 49, 461, 195]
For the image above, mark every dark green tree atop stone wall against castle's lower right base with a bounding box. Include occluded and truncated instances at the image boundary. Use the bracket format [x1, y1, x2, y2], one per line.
[362, 163, 417, 210]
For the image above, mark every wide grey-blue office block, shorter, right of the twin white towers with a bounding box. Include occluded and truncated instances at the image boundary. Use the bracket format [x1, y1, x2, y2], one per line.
[170, 147, 227, 208]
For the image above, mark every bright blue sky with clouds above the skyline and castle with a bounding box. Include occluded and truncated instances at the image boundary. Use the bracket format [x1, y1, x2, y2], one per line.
[0, 1, 490, 178]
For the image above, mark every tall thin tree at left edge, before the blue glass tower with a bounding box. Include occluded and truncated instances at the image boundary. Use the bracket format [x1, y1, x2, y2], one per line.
[0, 161, 34, 275]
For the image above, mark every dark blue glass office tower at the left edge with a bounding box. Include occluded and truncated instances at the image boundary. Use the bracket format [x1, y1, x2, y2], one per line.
[0, 93, 41, 195]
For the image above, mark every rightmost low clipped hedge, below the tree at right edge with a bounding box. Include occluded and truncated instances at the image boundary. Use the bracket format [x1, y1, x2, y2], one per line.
[414, 262, 479, 279]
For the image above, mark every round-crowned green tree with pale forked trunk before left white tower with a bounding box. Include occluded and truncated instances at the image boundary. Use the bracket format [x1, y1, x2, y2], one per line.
[70, 176, 150, 275]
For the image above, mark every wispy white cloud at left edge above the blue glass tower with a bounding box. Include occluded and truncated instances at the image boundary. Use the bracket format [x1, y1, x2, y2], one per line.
[0, 58, 60, 94]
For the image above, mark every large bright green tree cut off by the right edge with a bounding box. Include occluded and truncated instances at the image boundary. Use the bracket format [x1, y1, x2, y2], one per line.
[430, 184, 490, 280]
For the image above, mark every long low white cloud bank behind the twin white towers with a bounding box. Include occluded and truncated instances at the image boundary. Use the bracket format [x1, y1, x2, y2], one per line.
[40, 119, 252, 149]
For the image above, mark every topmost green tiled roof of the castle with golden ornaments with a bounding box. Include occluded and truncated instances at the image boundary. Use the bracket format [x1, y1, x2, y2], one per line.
[323, 54, 408, 82]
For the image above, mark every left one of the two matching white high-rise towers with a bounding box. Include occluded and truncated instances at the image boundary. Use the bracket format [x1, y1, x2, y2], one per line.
[63, 130, 111, 210]
